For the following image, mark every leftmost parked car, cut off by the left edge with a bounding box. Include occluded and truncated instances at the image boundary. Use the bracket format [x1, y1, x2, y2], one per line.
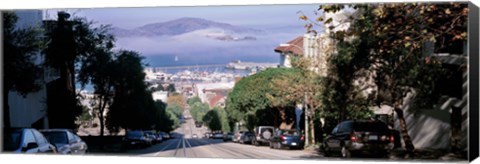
[3, 128, 57, 153]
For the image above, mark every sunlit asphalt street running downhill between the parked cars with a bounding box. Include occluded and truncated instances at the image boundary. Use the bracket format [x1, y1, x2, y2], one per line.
[118, 111, 322, 159]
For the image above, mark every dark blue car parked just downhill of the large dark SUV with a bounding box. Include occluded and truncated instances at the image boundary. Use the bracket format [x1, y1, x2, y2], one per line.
[269, 130, 305, 149]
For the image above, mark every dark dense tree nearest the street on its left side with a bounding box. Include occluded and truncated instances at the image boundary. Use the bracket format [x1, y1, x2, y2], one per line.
[106, 50, 154, 129]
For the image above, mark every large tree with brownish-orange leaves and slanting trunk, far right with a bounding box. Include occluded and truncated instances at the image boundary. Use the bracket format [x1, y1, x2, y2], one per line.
[308, 3, 468, 152]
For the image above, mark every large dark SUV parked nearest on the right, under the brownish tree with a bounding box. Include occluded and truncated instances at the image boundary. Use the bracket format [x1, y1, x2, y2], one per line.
[322, 120, 394, 158]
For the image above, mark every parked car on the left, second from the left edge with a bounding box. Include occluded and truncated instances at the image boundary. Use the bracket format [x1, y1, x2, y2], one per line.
[40, 129, 88, 154]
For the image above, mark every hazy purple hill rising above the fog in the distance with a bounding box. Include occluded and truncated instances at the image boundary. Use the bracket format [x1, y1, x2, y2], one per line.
[111, 17, 264, 41]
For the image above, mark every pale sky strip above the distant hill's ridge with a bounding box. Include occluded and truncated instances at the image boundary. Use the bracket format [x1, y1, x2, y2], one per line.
[50, 4, 318, 28]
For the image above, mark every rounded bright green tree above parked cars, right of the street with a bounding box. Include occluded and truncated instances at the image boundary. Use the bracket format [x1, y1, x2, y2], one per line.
[226, 68, 298, 129]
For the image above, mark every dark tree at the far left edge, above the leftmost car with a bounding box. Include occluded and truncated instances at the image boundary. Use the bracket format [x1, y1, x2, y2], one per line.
[2, 12, 43, 128]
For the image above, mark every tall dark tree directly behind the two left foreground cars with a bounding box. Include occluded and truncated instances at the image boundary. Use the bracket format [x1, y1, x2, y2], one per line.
[44, 11, 97, 129]
